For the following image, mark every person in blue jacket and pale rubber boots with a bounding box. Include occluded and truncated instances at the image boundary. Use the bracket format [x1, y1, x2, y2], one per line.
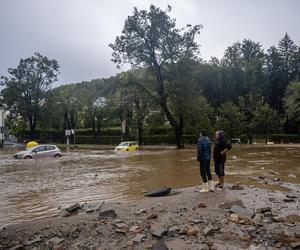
[197, 129, 214, 192]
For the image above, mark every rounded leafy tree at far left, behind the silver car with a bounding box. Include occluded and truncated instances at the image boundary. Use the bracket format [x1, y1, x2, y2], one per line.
[1, 53, 59, 136]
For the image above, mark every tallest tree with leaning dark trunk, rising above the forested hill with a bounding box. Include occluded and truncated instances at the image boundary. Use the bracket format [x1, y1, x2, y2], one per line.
[110, 5, 202, 148]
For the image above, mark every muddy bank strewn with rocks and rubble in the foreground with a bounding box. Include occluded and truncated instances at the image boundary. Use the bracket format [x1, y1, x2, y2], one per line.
[0, 183, 300, 250]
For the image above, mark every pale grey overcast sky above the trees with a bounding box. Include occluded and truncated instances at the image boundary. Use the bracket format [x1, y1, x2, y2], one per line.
[0, 0, 300, 85]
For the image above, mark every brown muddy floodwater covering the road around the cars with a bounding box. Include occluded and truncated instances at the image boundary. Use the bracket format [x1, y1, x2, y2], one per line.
[0, 145, 300, 226]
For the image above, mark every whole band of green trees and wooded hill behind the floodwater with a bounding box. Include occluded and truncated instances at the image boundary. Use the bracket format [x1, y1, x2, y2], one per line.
[1, 5, 300, 145]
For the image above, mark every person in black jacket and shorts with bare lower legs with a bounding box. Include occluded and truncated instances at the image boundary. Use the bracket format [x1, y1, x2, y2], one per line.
[213, 130, 231, 189]
